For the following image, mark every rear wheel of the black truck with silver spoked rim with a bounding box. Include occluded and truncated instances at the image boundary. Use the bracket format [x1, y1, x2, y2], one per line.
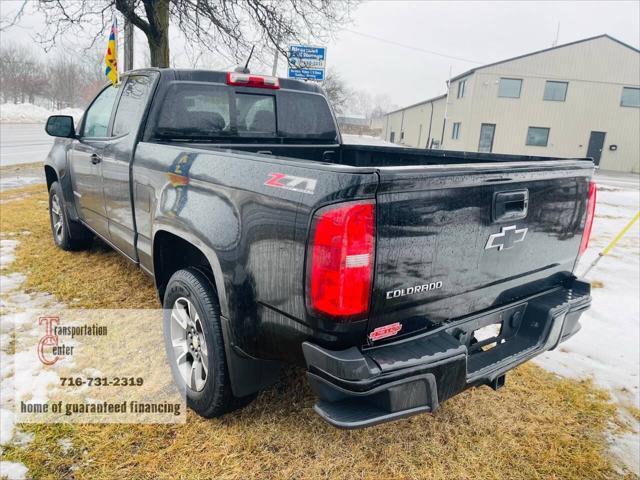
[163, 268, 255, 418]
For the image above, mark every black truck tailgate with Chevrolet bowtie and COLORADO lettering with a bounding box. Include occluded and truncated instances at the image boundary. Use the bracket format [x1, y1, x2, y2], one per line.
[369, 160, 593, 339]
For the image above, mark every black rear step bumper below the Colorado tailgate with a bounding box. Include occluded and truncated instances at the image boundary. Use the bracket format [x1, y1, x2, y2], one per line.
[302, 279, 591, 428]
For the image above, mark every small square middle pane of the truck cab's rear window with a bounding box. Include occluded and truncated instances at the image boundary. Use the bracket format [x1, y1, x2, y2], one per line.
[236, 93, 276, 136]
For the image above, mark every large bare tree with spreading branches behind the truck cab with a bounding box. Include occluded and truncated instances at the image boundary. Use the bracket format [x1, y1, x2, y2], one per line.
[1, 0, 358, 67]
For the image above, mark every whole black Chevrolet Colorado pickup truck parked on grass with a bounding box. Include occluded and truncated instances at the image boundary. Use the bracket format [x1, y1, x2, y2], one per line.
[44, 69, 596, 428]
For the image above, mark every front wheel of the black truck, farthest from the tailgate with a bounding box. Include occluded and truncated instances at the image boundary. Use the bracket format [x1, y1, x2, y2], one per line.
[49, 182, 93, 251]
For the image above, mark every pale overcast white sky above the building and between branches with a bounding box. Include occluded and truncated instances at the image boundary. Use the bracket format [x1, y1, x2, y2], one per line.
[0, 0, 640, 106]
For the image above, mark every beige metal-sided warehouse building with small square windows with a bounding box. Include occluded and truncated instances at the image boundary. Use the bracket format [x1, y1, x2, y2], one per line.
[383, 35, 640, 173]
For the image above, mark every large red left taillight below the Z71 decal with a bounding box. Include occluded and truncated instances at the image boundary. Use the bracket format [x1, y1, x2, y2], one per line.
[307, 201, 375, 321]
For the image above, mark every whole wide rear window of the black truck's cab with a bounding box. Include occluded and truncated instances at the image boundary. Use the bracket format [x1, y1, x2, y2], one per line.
[152, 82, 337, 143]
